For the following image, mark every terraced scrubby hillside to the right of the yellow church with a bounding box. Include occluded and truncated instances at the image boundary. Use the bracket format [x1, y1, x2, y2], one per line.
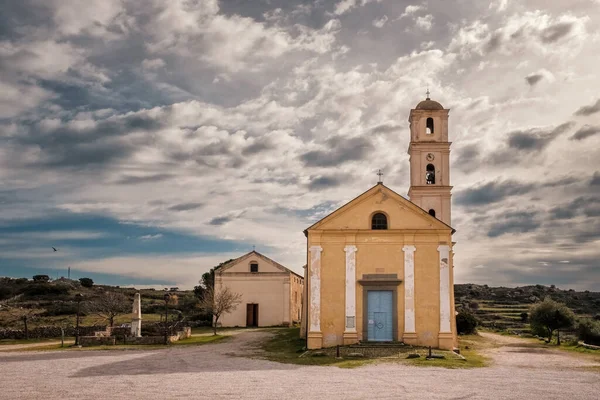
[454, 283, 600, 332]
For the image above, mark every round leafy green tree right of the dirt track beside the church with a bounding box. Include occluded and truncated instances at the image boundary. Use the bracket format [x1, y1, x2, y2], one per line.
[529, 297, 575, 345]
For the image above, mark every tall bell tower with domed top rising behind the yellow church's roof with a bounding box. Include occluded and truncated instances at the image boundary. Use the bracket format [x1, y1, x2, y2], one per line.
[408, 90, 452, 225]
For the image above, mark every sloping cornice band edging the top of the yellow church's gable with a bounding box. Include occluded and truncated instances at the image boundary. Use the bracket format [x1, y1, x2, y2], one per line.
[304, 183, 455, 235]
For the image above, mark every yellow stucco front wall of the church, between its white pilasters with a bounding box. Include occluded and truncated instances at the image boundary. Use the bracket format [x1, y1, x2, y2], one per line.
[306, 185, 457, 348]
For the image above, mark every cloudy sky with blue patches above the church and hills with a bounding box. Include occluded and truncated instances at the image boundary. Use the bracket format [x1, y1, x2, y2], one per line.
[0, 0, 600, 290]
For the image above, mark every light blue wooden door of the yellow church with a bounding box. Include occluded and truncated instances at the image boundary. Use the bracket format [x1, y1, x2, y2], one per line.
[367, 290, 394, 342]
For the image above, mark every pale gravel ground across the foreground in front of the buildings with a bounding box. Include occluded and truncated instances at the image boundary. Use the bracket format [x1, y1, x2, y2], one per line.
[0, 331, 600, 400]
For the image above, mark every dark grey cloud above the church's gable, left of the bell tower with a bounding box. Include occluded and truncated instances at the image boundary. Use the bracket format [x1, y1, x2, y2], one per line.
[300, 136, 373, 167]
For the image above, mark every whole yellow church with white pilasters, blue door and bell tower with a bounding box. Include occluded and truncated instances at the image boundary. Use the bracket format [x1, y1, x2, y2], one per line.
[302, 93, 458, 349]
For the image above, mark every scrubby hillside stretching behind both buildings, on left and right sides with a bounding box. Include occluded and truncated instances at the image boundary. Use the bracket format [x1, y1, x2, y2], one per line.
[0, 278, 600, 332]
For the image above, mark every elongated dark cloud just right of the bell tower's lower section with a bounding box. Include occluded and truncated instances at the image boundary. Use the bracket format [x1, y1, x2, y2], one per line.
[456, 180, 535, 206]
